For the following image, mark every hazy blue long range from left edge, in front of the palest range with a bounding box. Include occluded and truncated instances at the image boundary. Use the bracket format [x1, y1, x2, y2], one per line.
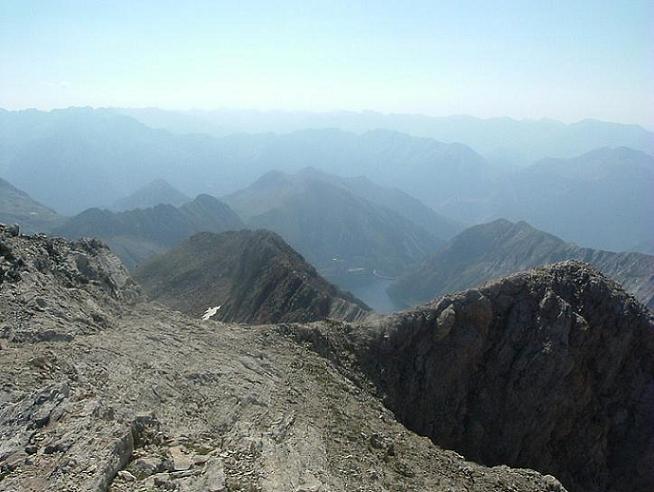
[0, 108, 491, 219]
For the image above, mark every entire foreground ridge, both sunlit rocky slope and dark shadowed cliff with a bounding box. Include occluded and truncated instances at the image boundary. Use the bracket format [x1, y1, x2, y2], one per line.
[0, 227, 654, 492]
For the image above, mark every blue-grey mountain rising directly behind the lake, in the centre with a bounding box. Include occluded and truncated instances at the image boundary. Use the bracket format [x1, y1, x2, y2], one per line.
[224, 171, 448, 283]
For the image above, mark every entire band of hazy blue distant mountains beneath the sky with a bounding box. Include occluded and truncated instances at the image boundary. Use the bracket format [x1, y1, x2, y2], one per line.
[0, 108, 654, 251]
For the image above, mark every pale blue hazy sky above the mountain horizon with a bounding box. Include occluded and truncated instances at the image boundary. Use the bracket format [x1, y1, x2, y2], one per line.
[0, 0, 654, 128]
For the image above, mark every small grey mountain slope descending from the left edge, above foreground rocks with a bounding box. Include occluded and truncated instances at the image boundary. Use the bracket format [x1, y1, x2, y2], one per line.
[0, 178, 63, 232]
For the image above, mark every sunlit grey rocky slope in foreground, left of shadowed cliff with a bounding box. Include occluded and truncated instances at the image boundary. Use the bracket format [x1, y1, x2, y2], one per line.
[0, 227, 568, 492]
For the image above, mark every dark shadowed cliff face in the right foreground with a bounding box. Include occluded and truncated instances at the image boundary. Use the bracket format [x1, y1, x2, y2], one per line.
[350, 262, 654, 492]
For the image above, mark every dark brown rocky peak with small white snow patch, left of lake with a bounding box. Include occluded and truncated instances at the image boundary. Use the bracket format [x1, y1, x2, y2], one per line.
[135, 231, 369, 324]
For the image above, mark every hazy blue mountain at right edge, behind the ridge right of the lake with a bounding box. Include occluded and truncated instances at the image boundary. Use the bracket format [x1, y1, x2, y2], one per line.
[495, 147, 654, 251]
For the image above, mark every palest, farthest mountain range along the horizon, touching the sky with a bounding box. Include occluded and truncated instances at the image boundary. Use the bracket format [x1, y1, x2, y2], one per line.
[116, 108, 654, 166]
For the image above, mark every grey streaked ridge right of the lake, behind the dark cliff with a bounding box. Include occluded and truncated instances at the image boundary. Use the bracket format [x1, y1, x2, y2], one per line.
[389, 219, 654, 308]
